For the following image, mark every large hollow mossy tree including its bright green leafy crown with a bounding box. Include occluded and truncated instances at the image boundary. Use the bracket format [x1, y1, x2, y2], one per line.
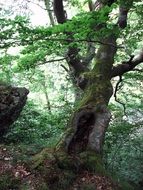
[0, 0, 143, 189]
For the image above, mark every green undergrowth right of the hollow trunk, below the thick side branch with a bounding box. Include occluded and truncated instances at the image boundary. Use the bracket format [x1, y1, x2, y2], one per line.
[104, 58, 143, 186]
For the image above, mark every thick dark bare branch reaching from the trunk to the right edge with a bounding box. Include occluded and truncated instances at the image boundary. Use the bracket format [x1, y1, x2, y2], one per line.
[111, 50, 143, 78]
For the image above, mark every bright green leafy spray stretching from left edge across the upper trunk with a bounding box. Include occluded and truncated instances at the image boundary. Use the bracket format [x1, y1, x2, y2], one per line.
[0, 6, 118, 70]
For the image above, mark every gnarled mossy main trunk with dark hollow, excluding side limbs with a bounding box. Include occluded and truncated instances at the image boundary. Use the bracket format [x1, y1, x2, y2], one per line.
[65, 36, 116, 154]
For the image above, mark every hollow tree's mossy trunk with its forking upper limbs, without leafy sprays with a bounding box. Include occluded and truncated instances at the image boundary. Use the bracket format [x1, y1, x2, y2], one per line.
[50, 0, 143, 154]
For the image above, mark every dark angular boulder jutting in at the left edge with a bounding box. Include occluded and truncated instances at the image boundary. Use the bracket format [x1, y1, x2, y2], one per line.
[0, 85, 29, 138]
